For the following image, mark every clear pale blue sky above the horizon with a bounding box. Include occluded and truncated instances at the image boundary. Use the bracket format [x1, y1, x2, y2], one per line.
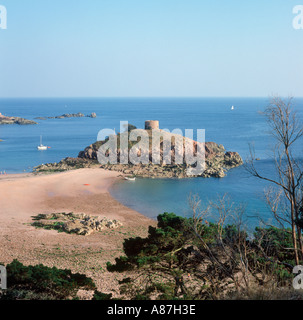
[0, 0, 303, 97]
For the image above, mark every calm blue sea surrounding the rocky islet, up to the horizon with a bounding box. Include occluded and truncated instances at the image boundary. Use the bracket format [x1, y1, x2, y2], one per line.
[0, 97, 303, 226]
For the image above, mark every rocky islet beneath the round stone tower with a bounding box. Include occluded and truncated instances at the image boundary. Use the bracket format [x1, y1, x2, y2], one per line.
[34, 122, 243, 178]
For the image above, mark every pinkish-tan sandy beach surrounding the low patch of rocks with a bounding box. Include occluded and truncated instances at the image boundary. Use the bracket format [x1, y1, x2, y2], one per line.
[0, 168, 156, 296]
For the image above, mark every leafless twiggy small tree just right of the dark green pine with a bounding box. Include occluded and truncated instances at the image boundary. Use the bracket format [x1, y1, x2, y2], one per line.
[189, 194, 252, 296]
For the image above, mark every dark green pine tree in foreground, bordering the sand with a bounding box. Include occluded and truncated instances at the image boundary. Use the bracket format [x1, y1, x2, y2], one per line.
[107, 213, 195, 299]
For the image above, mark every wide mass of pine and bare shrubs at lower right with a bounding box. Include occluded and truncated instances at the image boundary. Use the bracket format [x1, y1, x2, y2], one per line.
[107, 213, 295, 300]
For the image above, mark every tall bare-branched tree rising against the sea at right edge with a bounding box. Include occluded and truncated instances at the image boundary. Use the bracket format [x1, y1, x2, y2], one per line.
[246, 97, 303, 265]
